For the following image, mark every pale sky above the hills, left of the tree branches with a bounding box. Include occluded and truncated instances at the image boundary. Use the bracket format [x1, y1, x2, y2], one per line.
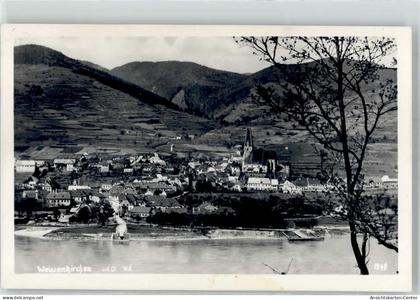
[16, 37, 269, 73]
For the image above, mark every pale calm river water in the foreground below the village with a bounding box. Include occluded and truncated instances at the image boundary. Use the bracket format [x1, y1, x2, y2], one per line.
[15, 236, 397, 274]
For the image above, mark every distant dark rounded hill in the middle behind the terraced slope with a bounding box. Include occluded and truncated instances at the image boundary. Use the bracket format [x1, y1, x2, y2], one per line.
[111, 61, 248, 117]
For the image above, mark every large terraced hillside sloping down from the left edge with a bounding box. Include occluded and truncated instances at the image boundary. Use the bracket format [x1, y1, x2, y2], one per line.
[14, 45, 217, 156]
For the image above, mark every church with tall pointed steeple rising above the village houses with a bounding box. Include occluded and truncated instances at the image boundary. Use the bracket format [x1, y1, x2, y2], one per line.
[242, 128, 277, 174]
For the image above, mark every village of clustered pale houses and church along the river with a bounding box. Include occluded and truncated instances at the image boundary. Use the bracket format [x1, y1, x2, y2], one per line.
[15, 129, 397, 227]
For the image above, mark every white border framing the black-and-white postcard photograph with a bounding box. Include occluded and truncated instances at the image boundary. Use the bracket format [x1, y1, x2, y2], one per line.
[0, 24, 412, 292]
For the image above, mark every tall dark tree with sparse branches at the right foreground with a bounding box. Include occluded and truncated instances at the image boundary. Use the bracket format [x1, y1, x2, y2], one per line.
[235, 37, 398, 274]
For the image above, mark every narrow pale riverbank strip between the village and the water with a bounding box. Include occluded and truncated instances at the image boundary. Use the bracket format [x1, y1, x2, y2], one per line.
[15, 224, 348, 241]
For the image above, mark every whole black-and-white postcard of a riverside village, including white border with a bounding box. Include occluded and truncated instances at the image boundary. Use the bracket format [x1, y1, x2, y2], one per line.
[1, 24, 412, 291]
